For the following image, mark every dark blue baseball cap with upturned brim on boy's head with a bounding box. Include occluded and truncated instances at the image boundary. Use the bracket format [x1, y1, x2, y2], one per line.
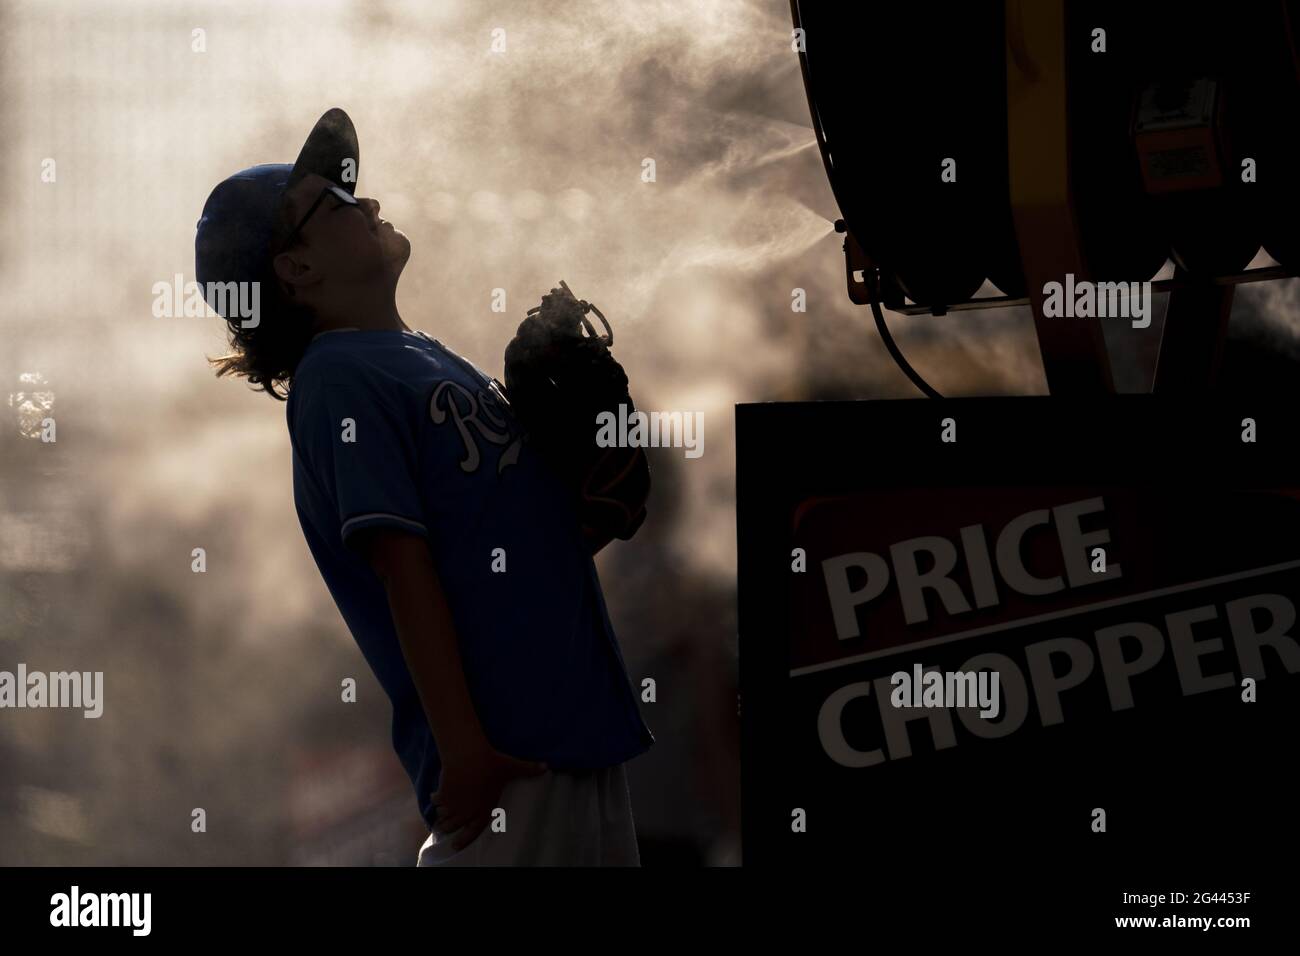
[194, 107, 360, 320]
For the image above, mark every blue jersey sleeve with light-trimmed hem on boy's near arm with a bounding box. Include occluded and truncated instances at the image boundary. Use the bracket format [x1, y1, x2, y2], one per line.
[294, 361, 429, 545]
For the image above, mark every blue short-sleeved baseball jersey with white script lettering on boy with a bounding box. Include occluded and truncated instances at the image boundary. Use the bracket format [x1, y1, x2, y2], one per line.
[286, 330, 654, 829]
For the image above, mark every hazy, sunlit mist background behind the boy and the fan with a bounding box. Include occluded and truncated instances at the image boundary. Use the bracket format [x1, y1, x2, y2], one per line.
[0, 0, 1300, 865]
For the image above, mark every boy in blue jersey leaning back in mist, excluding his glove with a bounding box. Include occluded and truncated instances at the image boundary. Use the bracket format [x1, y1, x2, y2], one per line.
[195, 109, 654, 866]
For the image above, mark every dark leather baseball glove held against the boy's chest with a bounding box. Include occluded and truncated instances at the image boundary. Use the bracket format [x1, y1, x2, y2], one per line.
[506, 280, 650, 544]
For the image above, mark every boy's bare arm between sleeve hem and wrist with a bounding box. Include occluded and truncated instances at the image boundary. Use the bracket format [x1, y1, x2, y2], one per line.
[381, 541, 486, 760]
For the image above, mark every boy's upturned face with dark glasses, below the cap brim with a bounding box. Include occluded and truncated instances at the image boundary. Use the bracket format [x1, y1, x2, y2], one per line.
[276, 173, 411, 287]
